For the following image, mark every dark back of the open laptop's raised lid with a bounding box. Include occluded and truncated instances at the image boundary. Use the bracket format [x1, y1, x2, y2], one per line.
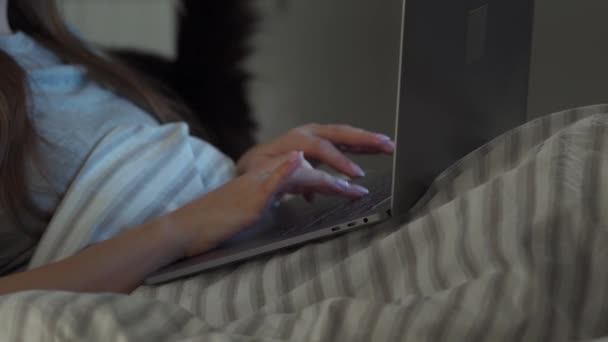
[392, 0, 534, 217]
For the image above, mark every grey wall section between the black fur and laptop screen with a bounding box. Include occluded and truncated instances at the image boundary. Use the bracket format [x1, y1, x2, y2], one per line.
[249, 0, 401, 142]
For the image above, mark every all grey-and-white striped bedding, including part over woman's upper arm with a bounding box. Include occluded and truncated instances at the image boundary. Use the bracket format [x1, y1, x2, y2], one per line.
[0, 105, 608, 342]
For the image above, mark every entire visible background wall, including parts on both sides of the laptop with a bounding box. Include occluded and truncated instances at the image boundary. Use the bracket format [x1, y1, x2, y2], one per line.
[62, 0, 608, 135]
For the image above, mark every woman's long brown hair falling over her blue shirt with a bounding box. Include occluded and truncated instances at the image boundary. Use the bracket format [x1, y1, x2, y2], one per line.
[0, 0, 196, 228]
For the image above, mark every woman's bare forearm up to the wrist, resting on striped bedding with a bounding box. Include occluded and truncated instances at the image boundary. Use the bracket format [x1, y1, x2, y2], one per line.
[0, 220, 184, 295]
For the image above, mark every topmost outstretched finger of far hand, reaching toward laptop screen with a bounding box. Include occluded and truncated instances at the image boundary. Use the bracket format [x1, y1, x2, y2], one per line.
[310, 125, 395, 153]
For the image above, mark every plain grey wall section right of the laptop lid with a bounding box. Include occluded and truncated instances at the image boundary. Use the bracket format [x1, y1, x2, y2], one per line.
[529, 0, 608, 116]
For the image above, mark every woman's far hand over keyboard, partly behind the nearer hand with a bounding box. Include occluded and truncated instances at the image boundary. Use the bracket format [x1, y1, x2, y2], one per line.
[237, 124, 395, 177]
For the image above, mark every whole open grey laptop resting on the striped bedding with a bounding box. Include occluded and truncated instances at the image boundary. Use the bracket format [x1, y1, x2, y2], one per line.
[146, 0, 534, 284]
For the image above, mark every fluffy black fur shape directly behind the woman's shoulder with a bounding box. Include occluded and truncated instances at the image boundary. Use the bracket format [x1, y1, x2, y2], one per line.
[112, 0, 257, 159]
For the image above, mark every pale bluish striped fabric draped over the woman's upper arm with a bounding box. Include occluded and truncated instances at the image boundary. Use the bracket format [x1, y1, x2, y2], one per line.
[29, 123, 235, 268]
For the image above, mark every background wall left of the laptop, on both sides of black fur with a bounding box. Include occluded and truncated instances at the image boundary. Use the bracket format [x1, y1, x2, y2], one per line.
[62, 0, 400, 144]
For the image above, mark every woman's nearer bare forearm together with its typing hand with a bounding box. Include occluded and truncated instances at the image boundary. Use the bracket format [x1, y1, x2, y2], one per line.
[0, 152, 361, 295]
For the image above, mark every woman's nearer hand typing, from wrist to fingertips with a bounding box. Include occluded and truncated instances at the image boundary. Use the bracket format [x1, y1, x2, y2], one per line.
[166, 151, 365, 256]
